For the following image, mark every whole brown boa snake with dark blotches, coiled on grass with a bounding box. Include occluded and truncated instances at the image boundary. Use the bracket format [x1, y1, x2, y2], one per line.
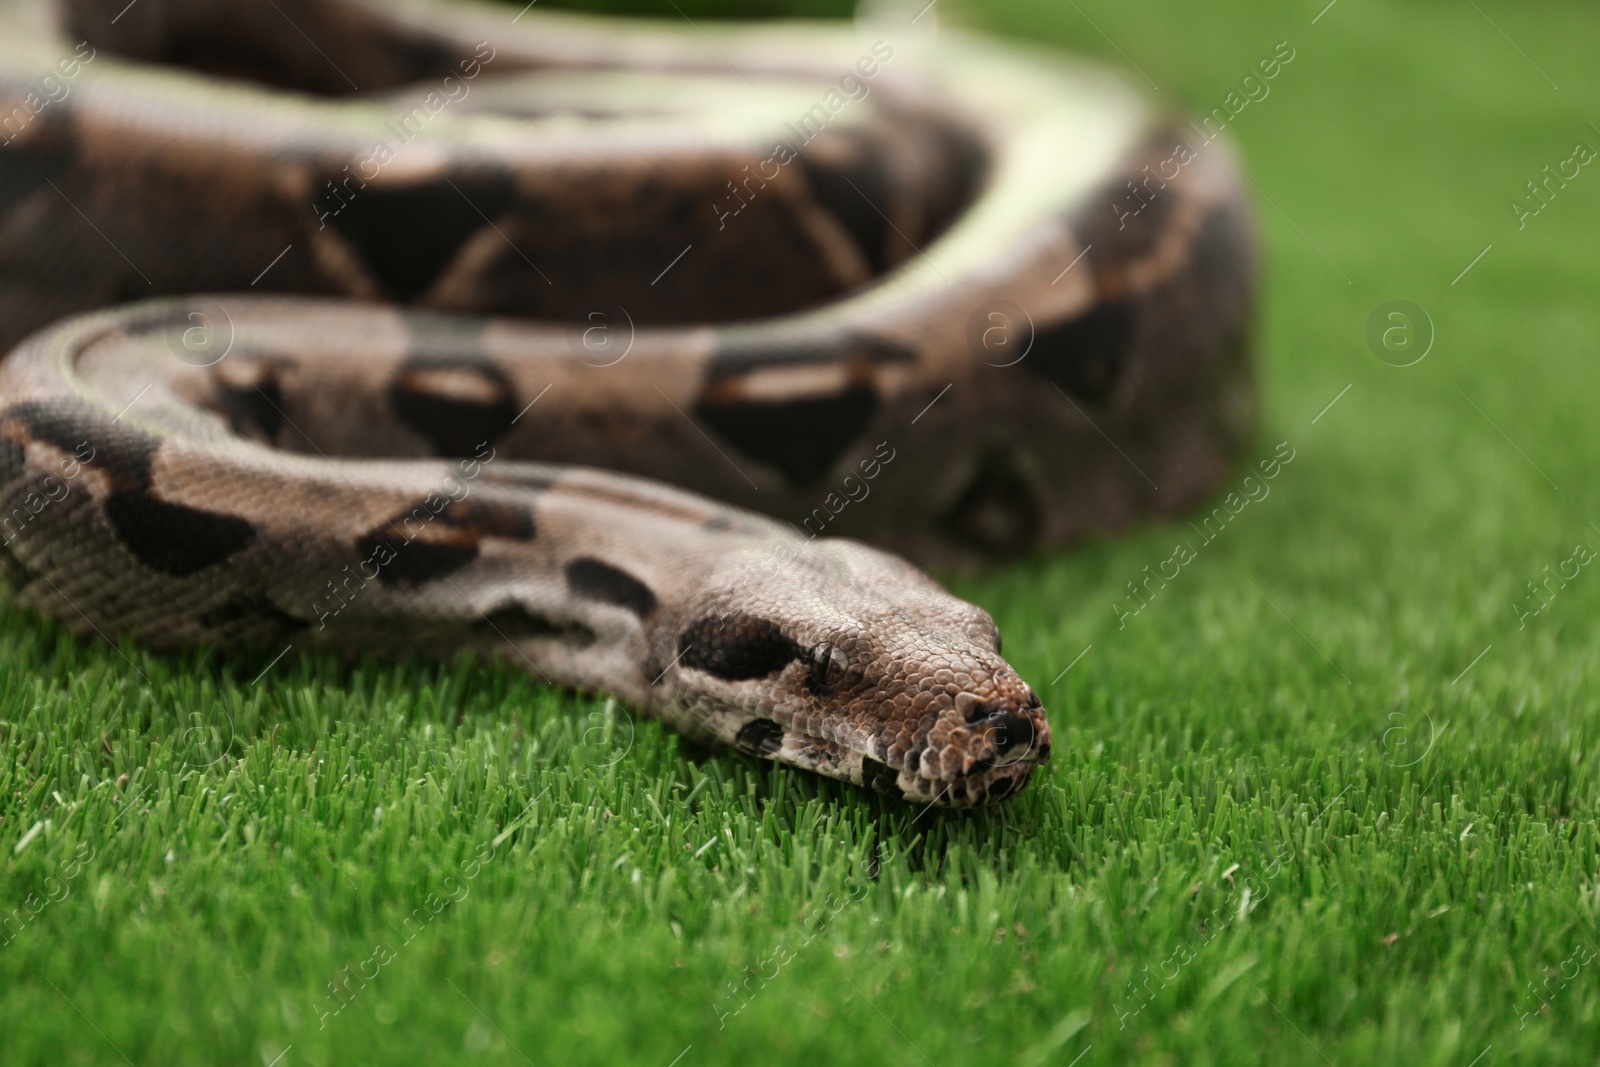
[0, 0, 1254, 806]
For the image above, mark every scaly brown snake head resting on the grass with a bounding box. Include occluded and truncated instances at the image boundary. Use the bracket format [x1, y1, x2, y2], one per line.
[653, 541, 1050, 806]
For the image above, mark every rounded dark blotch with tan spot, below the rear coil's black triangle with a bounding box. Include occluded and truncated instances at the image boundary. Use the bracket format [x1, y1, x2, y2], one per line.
[389, 355, 517, 456]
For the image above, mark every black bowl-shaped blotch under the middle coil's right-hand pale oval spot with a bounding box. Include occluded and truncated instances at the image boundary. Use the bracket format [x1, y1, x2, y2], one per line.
[694, 382, 878, 485]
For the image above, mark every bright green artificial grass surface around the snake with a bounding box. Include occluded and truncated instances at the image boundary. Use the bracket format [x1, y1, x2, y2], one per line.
[0, 0, 1600, 1067]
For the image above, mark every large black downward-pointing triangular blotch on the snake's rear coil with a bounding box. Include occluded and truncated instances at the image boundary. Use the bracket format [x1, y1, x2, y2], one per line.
[329, 173, 512, 304]
